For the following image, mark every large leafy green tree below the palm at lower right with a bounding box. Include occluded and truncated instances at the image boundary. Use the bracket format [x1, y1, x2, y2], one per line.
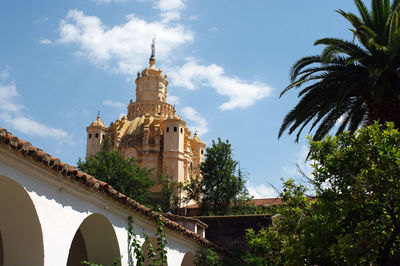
[247, 123, 400, 265]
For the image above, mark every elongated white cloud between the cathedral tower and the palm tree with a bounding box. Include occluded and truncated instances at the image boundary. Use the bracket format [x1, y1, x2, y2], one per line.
[170, 62, 272, 110]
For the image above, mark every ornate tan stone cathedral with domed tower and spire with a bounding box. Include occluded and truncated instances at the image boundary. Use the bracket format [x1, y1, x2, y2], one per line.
[86, 42, 206, 185]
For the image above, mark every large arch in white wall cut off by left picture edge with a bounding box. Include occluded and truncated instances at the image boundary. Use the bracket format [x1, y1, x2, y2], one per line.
[0, 176, 44, 265]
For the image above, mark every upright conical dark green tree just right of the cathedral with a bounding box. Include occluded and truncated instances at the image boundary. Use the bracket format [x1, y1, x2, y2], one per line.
[184, 138, 249, 215]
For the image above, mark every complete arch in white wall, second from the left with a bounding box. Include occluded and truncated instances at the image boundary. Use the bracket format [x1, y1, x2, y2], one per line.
[67, 213, 121, 266]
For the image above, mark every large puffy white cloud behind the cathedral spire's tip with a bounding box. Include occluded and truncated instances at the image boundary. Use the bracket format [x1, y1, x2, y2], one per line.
[59, 10, 193, 75]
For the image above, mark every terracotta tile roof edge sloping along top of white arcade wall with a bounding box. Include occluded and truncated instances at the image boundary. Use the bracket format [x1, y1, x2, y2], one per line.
[0, 127, 217, 248]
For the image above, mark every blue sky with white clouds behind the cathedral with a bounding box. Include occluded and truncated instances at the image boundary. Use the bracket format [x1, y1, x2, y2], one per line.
[0, 0, 355, 197]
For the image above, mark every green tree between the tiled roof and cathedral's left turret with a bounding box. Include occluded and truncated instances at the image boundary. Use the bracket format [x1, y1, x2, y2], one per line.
[78, 138, 154, 203]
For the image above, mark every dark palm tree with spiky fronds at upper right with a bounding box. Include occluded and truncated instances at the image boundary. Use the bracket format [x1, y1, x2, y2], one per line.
[279, 0, 400, 141]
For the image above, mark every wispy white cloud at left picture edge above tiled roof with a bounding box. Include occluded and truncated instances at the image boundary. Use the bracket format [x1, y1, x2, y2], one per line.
[0, 70, 71, 143]
